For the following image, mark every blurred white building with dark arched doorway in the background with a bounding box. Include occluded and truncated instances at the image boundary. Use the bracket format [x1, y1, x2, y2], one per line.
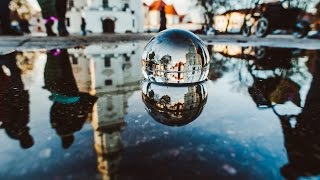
[66, 0, 144, 33]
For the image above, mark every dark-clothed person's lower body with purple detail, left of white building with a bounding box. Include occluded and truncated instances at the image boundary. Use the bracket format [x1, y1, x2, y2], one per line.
[38, 0, 69, 36]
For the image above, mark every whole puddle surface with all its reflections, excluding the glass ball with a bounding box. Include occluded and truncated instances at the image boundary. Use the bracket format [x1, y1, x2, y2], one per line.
[0, 42, 320, 179]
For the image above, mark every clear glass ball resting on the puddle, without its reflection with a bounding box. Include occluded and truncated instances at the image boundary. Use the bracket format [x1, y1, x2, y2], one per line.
[142, 29, 210, 84]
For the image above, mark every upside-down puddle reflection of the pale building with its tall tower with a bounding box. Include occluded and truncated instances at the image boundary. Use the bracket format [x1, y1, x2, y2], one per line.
[69, 42, 142, 179]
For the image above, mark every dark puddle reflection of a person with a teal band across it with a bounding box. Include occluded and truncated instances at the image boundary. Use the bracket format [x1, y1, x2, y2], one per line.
[44, 49, 97, 149]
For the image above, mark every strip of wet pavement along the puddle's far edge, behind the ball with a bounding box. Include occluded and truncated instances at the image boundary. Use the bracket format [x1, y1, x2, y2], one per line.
[0, 33, 320, 55]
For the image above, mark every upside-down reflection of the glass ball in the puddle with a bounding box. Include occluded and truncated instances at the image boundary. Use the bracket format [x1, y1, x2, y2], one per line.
[142, 81, 208, 126]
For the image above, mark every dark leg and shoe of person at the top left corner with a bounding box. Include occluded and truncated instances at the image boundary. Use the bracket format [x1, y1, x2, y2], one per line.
[0, 0, 22, 36]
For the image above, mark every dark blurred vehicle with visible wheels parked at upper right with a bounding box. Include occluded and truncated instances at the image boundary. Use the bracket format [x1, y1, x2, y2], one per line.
[242, 0, 310, 38]
